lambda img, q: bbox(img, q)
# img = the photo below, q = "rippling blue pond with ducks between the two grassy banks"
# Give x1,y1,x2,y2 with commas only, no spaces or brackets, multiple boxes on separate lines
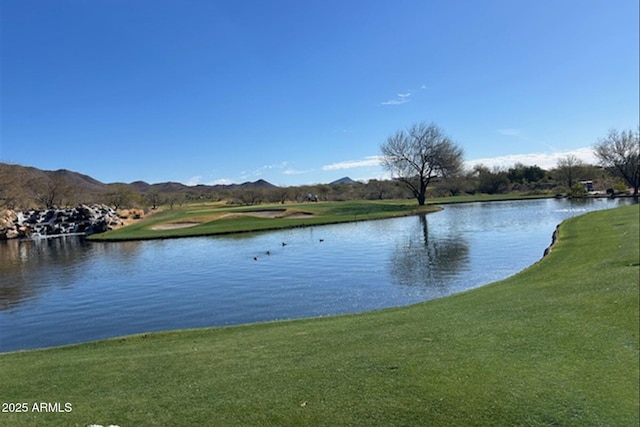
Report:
0,199,631,352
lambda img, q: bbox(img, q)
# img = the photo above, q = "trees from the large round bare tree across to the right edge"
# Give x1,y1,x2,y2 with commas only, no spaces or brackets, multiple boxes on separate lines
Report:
380,123,640,205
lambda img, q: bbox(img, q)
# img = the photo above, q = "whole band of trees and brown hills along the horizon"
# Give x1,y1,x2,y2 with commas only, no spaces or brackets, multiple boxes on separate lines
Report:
0,123,640,209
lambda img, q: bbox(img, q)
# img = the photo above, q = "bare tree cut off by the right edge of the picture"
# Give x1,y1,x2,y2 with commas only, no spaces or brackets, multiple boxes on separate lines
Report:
594,128,640,197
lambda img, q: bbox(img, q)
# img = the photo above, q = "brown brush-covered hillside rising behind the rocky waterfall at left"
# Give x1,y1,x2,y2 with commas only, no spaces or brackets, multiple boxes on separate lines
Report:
0,162,277,209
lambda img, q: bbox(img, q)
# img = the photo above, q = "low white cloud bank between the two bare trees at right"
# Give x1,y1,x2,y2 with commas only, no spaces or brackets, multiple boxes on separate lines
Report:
464,147,598,169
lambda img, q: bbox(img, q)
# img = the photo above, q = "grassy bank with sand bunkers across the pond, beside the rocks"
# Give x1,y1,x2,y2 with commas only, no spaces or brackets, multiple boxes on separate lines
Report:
90,200,437,241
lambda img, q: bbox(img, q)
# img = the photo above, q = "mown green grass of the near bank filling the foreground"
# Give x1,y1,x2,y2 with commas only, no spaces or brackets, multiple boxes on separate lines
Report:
0,205,640,427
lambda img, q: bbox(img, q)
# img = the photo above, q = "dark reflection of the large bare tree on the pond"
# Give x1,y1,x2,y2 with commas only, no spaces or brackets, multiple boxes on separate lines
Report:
389,215,469,288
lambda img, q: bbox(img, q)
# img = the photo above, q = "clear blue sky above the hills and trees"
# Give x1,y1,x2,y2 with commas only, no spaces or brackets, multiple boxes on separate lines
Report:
0,0,640,185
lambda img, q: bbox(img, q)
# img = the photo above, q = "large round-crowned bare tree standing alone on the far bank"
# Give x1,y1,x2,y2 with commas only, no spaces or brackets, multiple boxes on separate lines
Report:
380,123,463,206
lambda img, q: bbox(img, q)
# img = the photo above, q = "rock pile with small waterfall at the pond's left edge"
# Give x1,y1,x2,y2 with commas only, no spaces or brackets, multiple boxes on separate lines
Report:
0,205,144,240
